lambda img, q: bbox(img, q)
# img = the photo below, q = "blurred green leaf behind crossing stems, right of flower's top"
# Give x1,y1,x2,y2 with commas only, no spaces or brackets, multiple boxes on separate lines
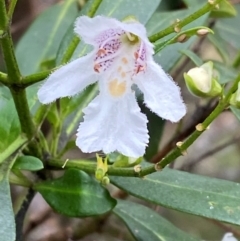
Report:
146,6,208,71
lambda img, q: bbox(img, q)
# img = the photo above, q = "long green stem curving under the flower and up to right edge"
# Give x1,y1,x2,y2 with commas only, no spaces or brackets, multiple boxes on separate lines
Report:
48,75,240,177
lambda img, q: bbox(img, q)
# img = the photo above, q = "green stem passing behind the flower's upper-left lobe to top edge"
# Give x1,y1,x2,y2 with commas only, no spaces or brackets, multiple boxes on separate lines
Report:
61,0,102,64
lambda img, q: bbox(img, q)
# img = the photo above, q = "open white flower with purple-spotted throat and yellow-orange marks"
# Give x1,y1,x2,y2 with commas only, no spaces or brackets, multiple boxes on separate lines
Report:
38,16,186,157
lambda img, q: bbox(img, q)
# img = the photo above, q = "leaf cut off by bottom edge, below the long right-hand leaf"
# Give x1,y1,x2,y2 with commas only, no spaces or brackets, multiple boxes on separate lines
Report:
113,200,198,241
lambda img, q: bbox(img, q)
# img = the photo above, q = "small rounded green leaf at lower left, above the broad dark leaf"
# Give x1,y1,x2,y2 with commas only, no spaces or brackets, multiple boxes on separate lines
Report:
12,156,43,171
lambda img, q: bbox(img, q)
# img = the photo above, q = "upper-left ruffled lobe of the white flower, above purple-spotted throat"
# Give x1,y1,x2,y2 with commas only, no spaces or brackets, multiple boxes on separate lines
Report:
74,16,121,45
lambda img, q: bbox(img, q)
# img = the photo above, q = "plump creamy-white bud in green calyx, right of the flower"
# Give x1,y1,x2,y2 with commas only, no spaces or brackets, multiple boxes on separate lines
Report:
184,61,222,97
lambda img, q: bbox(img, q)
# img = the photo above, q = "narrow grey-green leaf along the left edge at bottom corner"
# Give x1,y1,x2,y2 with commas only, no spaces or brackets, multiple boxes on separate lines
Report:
0,160,16,241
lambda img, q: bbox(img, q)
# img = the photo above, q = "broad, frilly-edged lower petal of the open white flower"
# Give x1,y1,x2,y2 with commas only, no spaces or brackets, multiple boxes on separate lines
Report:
76,93,149,157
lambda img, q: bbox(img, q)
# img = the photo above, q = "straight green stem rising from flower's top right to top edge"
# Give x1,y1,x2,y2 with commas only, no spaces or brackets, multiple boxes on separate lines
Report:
149,0,222,42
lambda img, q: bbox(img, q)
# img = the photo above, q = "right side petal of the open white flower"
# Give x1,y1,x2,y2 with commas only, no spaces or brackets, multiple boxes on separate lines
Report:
135,62,186,122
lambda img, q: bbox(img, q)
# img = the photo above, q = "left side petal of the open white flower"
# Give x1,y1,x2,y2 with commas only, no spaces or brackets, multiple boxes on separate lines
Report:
38,53,98,104
